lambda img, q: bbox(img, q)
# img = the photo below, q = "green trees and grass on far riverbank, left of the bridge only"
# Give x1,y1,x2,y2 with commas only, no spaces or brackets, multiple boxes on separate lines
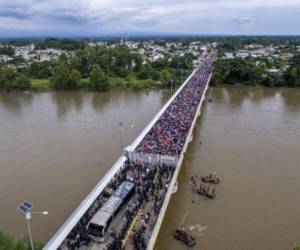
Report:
0,45,194,91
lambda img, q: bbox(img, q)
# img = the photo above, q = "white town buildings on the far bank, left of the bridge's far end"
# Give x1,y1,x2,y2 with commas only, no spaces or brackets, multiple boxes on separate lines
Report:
0,37,213,69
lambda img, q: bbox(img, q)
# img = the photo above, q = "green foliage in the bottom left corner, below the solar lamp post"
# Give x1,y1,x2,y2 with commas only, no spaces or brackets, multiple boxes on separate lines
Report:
0,231,43,250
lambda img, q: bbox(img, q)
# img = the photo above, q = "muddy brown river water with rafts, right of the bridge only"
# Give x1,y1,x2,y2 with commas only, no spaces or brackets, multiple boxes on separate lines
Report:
155,87,300,250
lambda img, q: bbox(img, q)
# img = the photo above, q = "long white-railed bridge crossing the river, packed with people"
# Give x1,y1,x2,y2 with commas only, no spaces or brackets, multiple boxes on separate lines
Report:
44,51,216,250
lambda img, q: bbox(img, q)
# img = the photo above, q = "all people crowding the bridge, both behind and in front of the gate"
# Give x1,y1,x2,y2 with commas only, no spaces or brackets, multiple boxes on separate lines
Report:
60,53,215,250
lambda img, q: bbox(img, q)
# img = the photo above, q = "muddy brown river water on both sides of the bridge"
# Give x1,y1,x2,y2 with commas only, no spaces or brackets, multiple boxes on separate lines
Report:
0,87,300,250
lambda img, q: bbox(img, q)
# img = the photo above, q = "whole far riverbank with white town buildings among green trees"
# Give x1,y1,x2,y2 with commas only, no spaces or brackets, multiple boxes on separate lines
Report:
0,36,300,91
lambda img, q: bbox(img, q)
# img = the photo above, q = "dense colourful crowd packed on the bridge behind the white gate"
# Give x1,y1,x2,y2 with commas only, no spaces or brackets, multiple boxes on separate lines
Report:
135,53,215,156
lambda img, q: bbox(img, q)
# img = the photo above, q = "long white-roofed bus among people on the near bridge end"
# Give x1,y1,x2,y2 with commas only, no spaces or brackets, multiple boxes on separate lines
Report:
87,180,135,242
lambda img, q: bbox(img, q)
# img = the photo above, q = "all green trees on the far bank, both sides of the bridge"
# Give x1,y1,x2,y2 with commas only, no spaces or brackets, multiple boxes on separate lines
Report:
0,36,300,91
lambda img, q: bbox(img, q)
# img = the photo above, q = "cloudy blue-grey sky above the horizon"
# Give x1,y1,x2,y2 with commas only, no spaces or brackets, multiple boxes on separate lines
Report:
0,0,300,37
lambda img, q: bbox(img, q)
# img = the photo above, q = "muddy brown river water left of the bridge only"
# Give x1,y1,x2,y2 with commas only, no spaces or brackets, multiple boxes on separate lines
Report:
0,91,170,241
